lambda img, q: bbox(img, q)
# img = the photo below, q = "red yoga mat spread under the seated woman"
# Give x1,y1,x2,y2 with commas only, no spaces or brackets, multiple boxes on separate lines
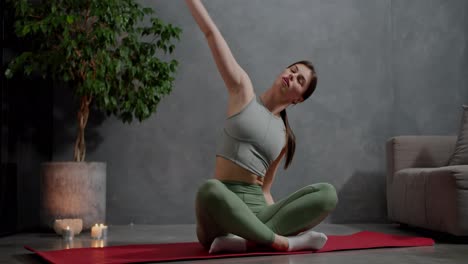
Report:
25,231,434,264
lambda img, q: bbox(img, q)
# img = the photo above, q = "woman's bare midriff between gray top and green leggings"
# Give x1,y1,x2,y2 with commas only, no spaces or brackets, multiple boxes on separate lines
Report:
215,156,263,186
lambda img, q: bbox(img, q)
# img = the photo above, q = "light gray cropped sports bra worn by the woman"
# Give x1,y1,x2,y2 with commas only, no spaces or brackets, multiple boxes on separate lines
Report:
216,95,286,177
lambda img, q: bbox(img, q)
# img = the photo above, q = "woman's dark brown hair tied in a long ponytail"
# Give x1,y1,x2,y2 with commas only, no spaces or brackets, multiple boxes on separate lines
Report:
280,60,317,169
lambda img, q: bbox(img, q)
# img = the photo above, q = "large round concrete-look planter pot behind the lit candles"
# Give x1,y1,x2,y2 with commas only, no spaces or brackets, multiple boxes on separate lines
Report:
40,162,106,230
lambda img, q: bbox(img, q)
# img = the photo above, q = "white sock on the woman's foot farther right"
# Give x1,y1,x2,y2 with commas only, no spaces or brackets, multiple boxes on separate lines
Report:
287,230,328,251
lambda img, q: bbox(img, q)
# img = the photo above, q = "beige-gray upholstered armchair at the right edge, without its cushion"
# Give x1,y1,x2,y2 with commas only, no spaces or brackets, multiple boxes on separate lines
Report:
386,136,468,236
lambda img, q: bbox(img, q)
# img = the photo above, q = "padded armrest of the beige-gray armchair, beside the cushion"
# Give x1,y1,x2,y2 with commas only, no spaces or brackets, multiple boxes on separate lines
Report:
386,136,457,183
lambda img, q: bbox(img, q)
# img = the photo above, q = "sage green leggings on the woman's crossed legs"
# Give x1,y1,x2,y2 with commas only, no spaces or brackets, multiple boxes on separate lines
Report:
195,179,338,248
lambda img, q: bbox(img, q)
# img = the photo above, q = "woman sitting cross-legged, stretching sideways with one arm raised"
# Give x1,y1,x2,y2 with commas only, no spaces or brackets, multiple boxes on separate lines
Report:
186,0,337,253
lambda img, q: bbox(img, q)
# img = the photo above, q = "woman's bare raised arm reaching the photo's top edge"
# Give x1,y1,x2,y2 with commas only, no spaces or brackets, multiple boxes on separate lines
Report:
185,0,253,94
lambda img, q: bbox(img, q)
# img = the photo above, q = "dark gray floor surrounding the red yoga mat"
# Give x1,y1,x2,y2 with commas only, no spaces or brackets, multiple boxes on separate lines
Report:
0,224,468,264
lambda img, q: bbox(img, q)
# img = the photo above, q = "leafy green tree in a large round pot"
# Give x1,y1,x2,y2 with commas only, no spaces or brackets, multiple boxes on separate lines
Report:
5,0,181,229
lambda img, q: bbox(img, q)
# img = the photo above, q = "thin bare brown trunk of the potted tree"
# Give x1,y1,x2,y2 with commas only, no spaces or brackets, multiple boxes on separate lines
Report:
74,95,92,162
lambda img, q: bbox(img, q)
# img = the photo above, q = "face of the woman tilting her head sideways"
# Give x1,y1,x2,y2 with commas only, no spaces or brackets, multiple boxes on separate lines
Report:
275,64,312,104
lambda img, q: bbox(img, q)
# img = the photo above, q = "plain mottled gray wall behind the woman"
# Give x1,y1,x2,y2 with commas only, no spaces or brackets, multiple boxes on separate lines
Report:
50,0,468,224
